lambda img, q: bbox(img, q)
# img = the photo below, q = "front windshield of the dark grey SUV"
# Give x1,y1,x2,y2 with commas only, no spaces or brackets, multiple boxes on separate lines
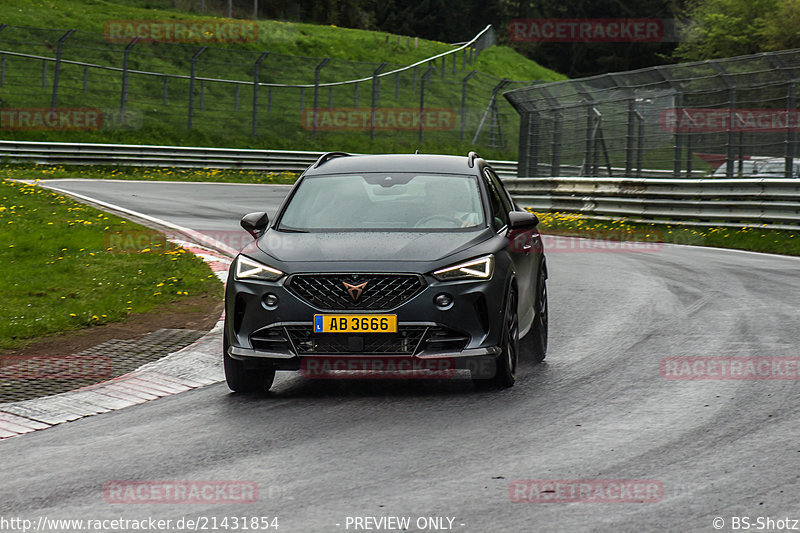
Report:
278,173,485,231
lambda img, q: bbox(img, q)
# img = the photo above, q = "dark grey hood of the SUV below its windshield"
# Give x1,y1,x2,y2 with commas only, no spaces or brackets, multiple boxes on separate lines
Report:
258,228,492,262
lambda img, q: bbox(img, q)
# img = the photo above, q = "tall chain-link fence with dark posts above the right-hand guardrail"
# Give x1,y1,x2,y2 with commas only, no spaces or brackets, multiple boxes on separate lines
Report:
505,50,800,178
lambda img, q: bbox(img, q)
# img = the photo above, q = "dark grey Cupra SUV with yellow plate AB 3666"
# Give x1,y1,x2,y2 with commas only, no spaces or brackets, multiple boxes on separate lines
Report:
224,152,547,391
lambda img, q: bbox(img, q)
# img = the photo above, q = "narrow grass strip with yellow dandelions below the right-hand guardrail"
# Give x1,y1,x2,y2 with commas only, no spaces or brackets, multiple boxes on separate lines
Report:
536,212,800,255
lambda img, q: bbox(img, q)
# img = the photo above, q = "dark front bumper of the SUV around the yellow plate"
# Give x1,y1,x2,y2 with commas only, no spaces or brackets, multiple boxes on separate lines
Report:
225,266,506,370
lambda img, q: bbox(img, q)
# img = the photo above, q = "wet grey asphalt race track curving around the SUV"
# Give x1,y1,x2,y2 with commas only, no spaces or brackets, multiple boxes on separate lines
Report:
0,181,800,532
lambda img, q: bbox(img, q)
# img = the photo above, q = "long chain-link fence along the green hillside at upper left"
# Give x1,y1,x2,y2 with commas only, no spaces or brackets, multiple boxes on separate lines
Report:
0,21,531,151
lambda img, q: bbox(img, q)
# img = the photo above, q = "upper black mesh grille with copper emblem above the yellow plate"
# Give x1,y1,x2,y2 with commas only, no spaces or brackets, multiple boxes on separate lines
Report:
286,274,425,311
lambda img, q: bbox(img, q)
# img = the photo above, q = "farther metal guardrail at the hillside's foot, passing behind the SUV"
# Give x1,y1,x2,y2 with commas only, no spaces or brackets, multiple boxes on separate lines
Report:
0,141,517,178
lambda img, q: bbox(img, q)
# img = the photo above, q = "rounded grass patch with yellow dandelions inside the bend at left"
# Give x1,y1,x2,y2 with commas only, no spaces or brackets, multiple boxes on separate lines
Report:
0,179,222,349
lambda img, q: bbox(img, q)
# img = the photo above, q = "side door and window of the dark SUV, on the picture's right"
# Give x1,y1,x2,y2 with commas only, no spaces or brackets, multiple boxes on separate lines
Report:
483,168,541,324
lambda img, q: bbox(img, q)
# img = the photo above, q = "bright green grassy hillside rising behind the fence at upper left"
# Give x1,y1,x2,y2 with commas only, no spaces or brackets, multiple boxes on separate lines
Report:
0,0,563,157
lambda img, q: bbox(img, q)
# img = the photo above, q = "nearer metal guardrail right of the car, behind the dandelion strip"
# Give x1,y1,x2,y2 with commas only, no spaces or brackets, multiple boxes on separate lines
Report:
503,177,800,230
